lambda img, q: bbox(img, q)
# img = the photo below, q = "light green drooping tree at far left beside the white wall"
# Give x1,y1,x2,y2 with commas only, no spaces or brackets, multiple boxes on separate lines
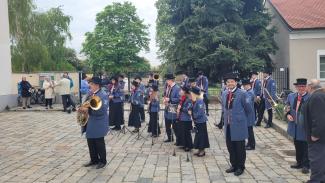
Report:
9,0,75,72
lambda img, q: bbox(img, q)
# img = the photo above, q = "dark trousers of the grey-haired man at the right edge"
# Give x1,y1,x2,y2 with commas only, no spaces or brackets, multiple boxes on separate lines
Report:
308,142,325,183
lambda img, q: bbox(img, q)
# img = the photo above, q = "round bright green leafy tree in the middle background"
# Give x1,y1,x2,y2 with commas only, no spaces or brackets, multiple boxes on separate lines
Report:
82,2,149,73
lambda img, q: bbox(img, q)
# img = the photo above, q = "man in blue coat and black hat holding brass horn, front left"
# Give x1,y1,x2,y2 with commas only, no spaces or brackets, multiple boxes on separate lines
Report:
78,77,108,169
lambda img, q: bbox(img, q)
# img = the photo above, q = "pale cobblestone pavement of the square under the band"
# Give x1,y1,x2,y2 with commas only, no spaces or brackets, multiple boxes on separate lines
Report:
0,108,308,183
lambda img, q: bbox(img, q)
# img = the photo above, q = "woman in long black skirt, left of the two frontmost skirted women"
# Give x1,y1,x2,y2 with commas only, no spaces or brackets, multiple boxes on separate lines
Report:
177,86,193,151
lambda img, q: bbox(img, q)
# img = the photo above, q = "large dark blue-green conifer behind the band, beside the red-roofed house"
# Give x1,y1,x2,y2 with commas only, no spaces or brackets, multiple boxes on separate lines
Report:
157,0,276,78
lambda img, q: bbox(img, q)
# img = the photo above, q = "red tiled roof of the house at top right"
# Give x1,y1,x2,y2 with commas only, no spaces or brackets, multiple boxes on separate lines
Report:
269,0,325,29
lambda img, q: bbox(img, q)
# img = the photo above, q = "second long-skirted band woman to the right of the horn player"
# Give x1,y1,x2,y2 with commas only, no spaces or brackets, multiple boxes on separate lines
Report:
128,81,142,133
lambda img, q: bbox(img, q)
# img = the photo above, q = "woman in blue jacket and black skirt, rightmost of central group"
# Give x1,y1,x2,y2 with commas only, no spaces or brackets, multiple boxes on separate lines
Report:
191,87,210,157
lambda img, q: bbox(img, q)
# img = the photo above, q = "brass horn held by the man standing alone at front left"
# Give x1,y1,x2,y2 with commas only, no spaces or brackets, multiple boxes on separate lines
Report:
77,95,102,126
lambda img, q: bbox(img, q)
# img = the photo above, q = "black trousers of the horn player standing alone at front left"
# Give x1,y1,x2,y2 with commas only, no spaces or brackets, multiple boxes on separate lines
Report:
87,137,107,164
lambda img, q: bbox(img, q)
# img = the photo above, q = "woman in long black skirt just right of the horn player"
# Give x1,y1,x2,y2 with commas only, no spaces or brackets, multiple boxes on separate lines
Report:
108,77,124,130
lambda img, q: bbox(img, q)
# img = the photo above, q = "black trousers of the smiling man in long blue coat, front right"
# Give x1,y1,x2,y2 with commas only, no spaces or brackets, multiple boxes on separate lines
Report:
226,125,246,169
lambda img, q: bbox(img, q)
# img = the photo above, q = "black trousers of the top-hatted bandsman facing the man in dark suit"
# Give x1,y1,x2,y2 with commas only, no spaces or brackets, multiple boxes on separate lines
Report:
294,140,309,168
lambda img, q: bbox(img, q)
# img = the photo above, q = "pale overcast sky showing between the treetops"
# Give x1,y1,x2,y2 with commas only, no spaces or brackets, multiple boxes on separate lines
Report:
35,0,160,66
